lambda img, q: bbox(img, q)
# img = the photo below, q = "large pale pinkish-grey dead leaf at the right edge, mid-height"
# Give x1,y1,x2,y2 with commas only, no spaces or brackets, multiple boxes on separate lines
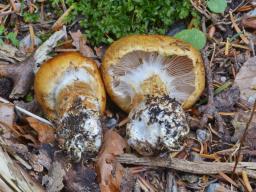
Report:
234,57,256,105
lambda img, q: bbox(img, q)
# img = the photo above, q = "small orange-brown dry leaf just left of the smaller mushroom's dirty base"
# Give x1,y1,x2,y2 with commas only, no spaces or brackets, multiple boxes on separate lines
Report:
26,117,55,143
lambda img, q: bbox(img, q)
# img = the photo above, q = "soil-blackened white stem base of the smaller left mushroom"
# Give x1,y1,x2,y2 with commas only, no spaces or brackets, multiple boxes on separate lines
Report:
57,106,102,161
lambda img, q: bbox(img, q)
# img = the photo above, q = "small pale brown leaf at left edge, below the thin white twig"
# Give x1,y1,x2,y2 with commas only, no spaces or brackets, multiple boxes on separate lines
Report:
0,103,15,129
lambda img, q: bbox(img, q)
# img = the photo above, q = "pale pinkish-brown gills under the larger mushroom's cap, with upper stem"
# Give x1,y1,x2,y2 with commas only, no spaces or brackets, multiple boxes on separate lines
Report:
109,51,195,108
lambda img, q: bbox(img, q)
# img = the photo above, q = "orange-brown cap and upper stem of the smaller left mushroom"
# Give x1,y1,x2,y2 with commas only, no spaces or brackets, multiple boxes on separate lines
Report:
34,52,106,119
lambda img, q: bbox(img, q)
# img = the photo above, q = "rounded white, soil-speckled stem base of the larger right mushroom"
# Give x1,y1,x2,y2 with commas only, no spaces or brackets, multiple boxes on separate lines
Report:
127,96,189,155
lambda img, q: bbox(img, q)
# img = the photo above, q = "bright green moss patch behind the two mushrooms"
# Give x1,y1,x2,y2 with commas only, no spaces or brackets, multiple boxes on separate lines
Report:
52,0,198,46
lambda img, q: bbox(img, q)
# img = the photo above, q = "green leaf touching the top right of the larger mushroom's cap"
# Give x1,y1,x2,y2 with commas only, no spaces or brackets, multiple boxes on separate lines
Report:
175,28,206,49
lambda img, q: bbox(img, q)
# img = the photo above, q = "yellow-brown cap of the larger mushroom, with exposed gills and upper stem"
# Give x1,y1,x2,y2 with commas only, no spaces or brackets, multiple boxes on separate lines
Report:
102,35,205,112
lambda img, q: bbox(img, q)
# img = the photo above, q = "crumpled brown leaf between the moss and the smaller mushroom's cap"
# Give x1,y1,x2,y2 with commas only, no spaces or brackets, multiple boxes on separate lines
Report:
70,30,95,58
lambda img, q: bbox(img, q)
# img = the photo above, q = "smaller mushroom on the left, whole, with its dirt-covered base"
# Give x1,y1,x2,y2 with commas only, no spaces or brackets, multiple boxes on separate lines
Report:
34,52,106,161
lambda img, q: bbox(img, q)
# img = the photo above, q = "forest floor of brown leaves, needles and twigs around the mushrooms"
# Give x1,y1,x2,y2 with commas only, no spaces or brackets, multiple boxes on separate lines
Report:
0,0,256,192
